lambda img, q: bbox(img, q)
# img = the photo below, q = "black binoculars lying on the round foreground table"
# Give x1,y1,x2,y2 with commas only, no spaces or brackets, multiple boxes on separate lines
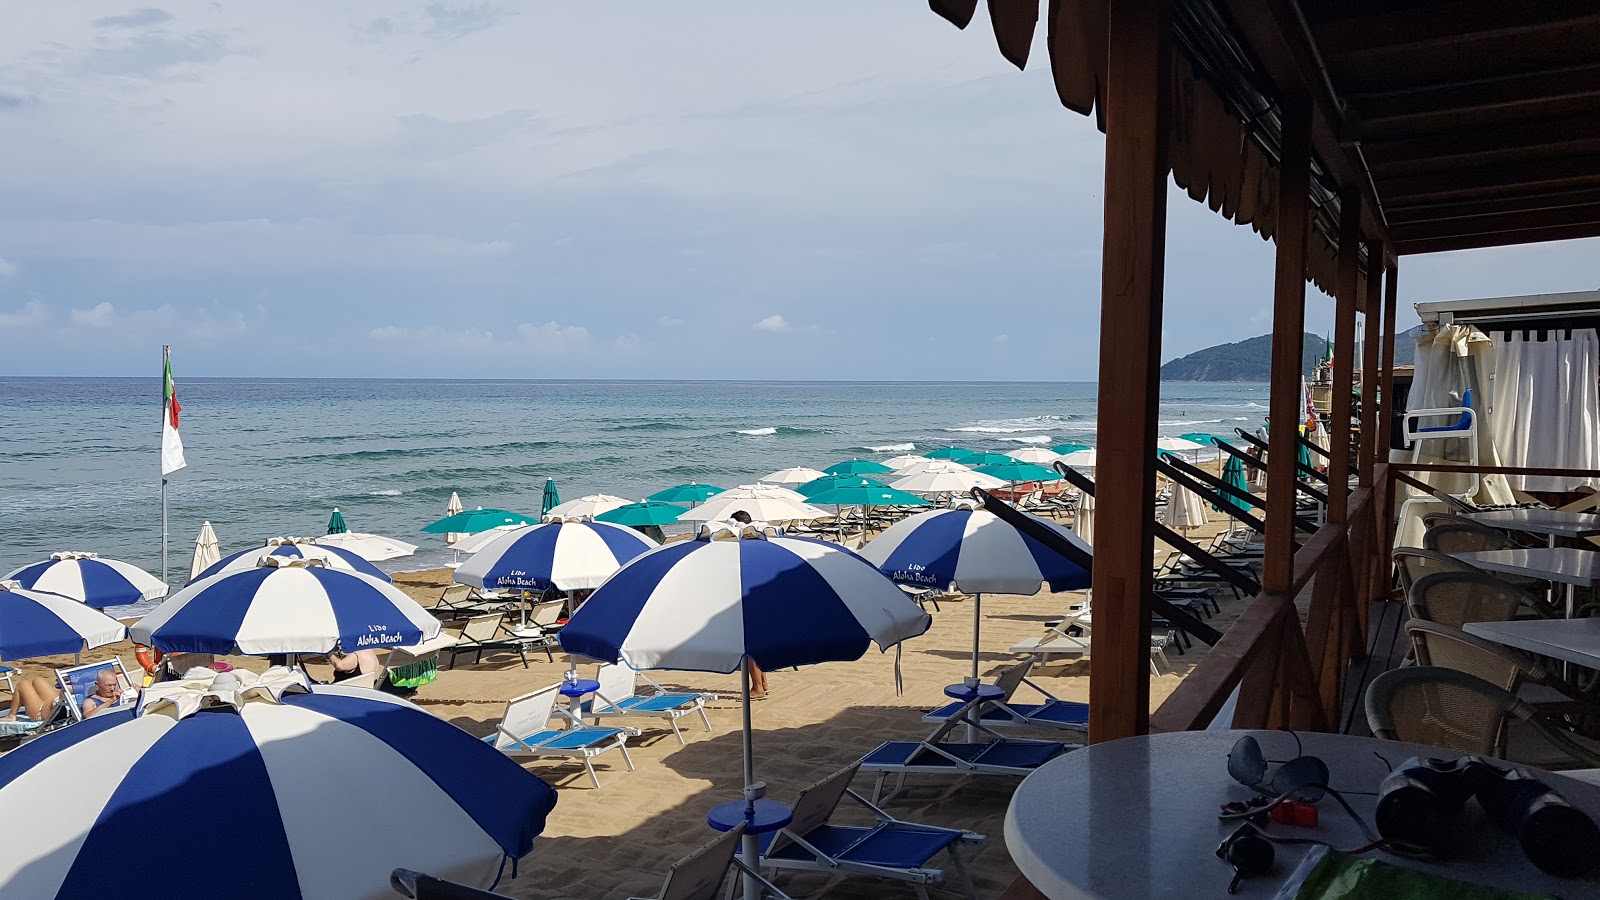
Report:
1376,756,1600,878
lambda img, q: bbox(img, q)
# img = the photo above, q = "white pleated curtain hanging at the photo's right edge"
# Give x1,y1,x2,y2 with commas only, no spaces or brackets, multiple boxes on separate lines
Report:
1488,328,1600,492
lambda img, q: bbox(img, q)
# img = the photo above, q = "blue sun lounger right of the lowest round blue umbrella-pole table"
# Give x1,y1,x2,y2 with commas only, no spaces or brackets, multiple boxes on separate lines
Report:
762,762,984,900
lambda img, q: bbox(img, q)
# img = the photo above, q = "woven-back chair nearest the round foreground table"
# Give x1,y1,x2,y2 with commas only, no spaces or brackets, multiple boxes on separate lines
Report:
1366,666,1600,767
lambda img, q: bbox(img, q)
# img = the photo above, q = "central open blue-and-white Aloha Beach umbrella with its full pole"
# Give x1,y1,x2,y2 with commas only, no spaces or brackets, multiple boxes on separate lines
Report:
560,538,933,900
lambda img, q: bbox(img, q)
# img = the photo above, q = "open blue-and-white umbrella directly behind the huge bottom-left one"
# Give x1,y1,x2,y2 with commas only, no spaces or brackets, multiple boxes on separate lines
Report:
133,556,438,655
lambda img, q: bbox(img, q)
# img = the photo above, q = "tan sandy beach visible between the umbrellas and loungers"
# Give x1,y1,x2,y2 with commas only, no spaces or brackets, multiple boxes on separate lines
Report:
6,493,1242,900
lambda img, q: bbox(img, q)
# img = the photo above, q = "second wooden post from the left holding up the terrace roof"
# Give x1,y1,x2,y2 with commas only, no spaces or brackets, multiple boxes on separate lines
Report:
1260,98,1310,595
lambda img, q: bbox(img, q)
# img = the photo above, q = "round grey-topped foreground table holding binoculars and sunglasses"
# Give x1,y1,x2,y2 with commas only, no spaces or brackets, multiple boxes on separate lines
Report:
1005,732,1600,900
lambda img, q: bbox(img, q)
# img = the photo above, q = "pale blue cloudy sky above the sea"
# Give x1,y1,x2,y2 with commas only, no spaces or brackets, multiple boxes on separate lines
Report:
0,0,1600,381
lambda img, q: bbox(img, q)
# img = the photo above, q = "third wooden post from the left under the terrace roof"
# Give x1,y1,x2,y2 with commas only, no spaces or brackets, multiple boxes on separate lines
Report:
1328,191,1362,522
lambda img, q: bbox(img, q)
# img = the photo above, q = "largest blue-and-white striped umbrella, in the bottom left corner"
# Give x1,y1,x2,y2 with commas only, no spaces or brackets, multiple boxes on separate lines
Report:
0,669,555,900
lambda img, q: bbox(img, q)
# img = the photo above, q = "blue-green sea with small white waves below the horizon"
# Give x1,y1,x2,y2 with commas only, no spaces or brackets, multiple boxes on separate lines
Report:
0,378,1267,595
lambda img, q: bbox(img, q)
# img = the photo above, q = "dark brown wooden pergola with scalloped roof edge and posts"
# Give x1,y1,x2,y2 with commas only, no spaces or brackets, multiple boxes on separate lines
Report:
930,0,1600,741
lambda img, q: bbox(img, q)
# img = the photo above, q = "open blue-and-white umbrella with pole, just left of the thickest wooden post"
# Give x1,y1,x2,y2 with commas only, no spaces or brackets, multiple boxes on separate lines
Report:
861,509,1093,679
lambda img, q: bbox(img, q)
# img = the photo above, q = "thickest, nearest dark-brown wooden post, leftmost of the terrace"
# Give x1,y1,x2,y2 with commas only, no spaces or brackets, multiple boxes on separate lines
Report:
1090,0,1173,741
